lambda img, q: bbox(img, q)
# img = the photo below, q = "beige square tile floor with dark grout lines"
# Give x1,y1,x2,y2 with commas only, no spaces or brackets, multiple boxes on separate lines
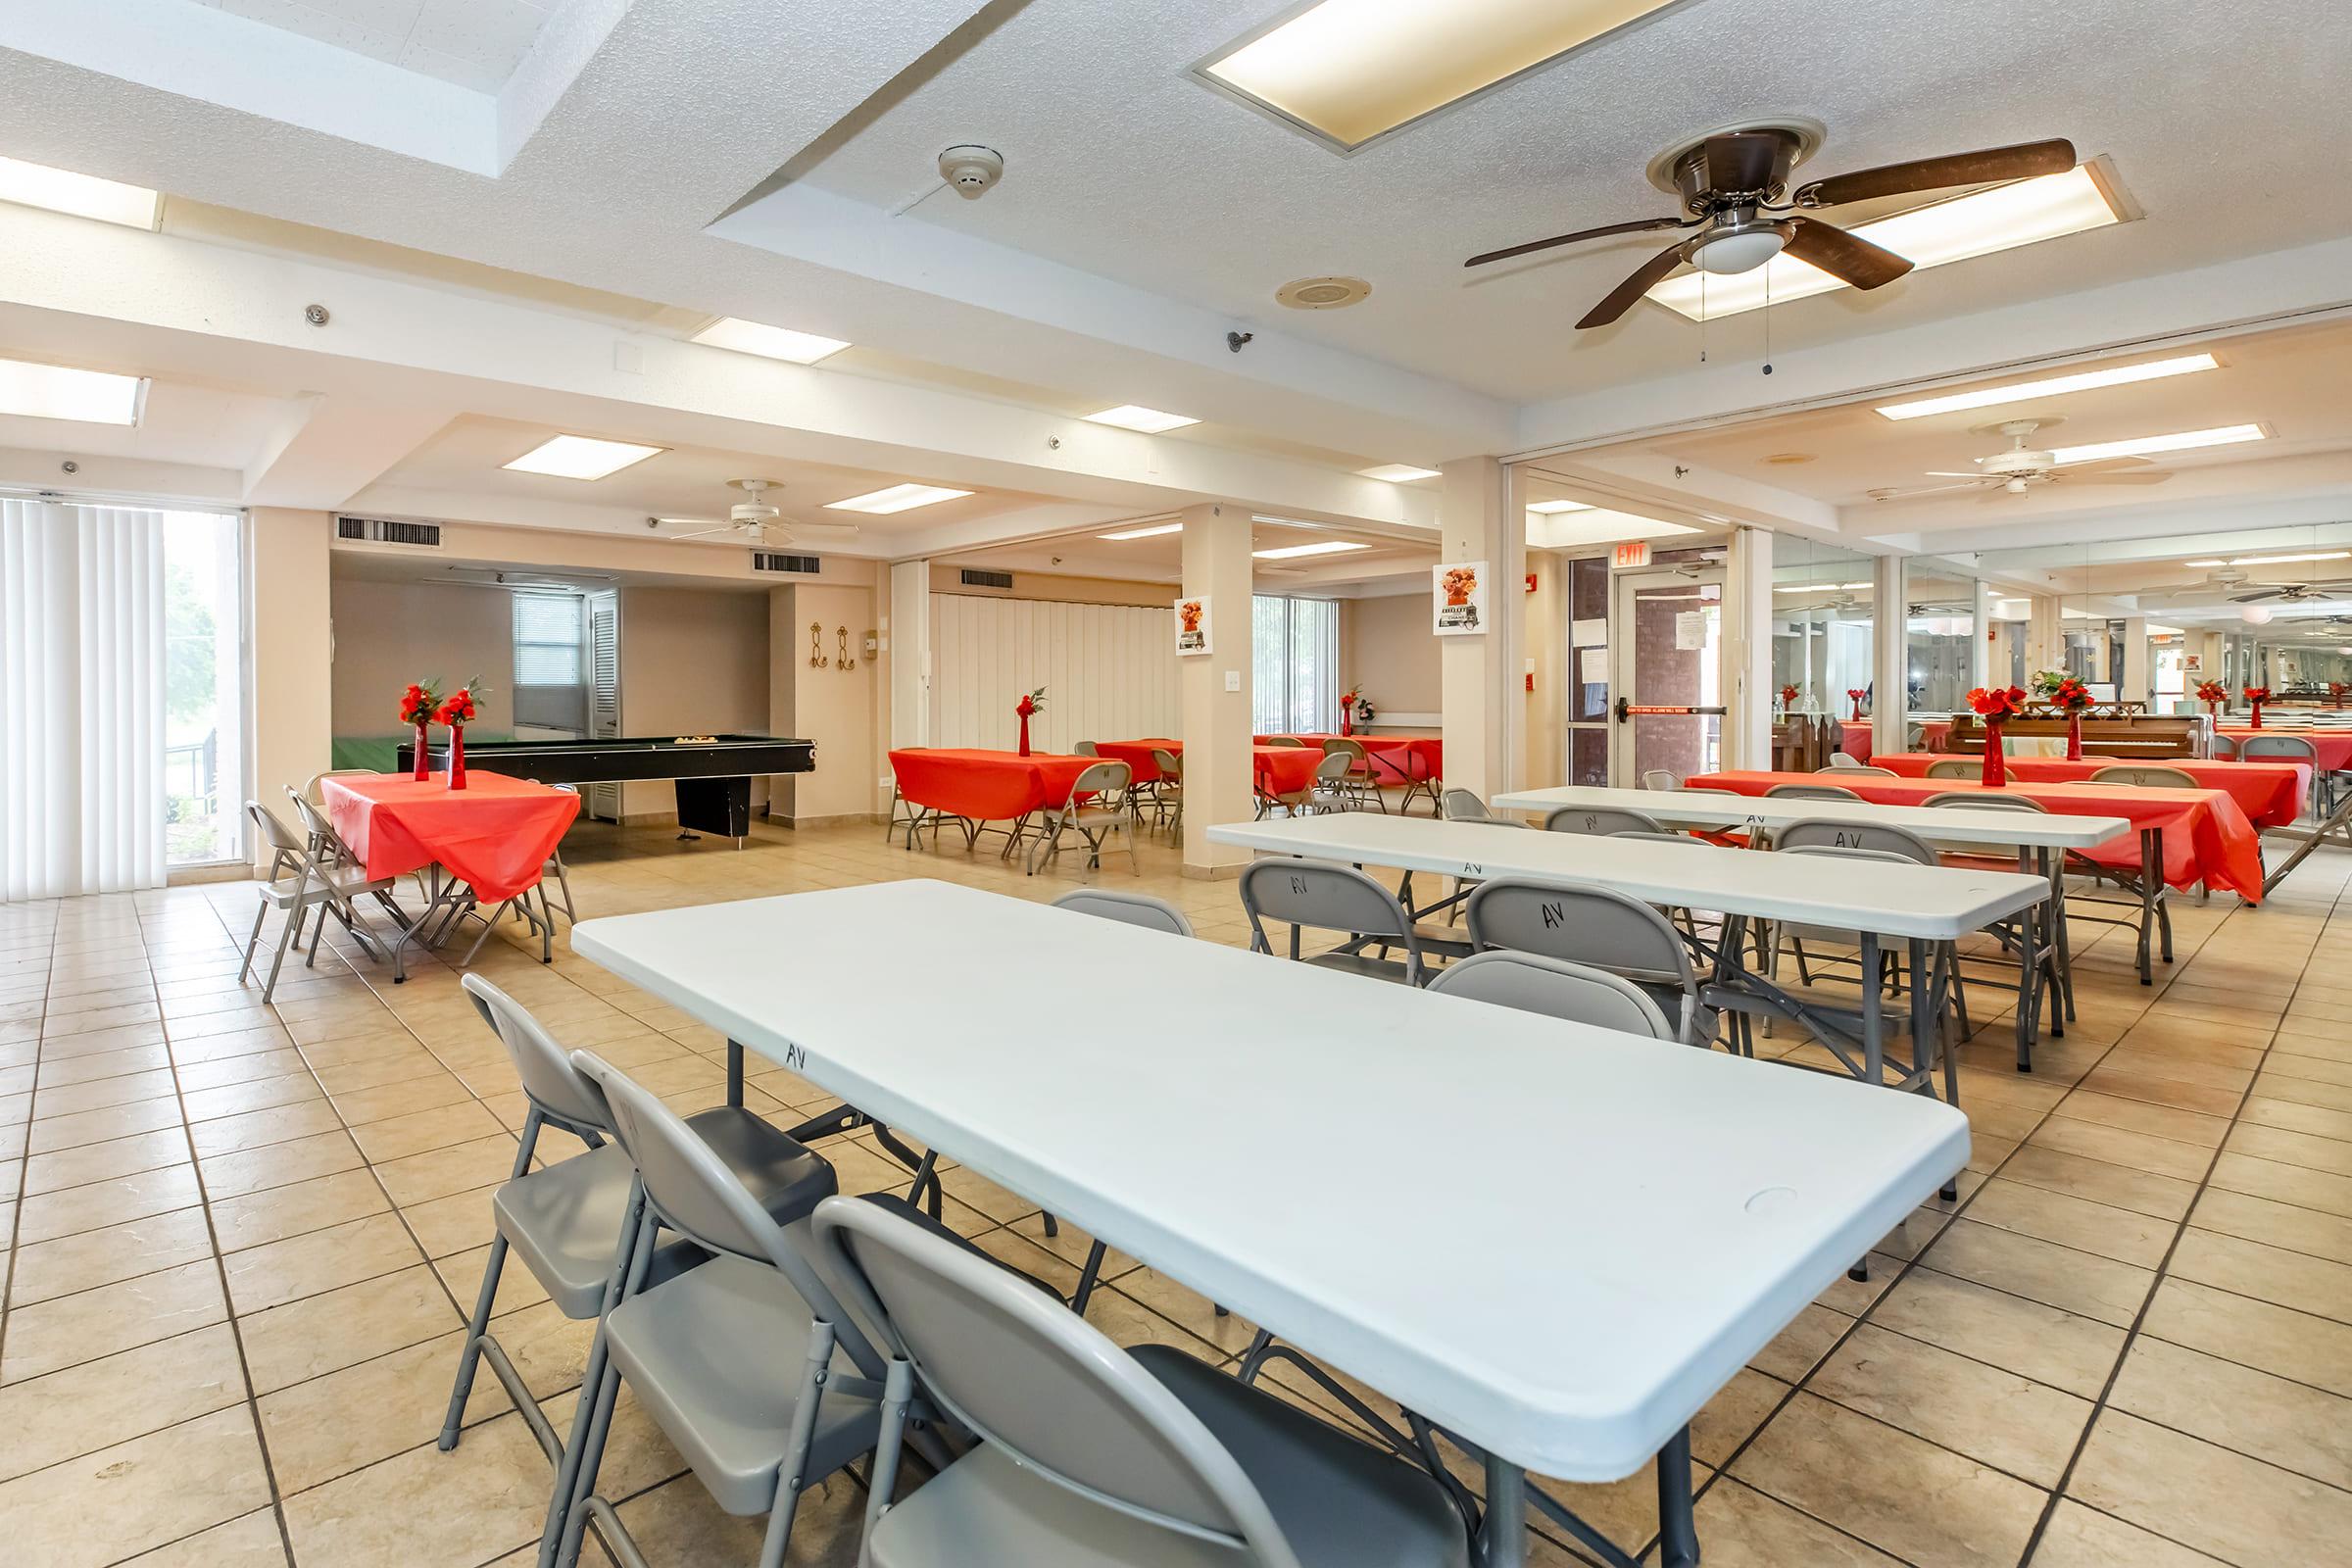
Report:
0,808,2352,1568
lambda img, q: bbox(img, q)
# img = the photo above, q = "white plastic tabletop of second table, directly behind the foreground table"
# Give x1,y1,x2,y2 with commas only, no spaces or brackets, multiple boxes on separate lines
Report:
1209,802,2051,943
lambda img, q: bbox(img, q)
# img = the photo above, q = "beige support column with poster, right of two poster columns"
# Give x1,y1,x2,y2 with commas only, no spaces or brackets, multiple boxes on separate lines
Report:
1437,459,1527,797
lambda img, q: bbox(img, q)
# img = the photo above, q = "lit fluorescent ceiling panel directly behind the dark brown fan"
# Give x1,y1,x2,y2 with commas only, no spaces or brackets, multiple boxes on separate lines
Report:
1648,165,2124,322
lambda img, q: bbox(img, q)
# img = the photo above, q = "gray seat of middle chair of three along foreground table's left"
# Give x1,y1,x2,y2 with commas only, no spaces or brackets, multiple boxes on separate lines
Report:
605,1257,882,1514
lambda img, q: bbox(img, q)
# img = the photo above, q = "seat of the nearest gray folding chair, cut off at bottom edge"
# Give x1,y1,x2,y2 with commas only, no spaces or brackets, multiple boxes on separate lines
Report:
870,1345,1470,1568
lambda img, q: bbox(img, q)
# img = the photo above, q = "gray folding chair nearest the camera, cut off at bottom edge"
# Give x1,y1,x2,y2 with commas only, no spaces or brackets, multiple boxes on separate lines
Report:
816,1199,1470,1568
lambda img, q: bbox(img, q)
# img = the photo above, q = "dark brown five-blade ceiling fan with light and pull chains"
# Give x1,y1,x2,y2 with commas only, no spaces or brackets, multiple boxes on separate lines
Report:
1463,124,2075,329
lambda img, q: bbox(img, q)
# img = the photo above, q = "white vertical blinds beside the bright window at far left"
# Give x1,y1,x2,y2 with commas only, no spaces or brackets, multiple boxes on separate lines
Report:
0,501,165,903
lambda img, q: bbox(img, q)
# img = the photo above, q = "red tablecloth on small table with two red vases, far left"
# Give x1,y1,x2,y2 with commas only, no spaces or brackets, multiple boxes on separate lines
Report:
319,768,581,903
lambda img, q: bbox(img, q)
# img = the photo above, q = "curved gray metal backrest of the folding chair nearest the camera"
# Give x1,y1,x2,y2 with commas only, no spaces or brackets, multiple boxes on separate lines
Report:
816,1197,1298,1568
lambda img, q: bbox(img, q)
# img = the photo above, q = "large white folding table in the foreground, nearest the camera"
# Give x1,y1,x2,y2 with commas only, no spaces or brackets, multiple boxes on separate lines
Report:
571,883,1969,1568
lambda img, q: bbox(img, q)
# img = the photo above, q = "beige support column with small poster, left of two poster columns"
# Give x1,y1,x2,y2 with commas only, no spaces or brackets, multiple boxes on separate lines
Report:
1176,506,1253,877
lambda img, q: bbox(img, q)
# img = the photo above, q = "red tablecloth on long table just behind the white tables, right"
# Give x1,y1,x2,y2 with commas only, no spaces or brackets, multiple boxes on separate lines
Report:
1689,771,2263,903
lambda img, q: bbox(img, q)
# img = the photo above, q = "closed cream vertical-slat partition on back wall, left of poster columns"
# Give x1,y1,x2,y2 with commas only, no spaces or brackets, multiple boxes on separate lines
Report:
929,592,1171,753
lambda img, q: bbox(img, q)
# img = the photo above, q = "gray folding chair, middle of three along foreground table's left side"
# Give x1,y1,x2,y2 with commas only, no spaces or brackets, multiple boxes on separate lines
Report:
541,1051,884,1568
